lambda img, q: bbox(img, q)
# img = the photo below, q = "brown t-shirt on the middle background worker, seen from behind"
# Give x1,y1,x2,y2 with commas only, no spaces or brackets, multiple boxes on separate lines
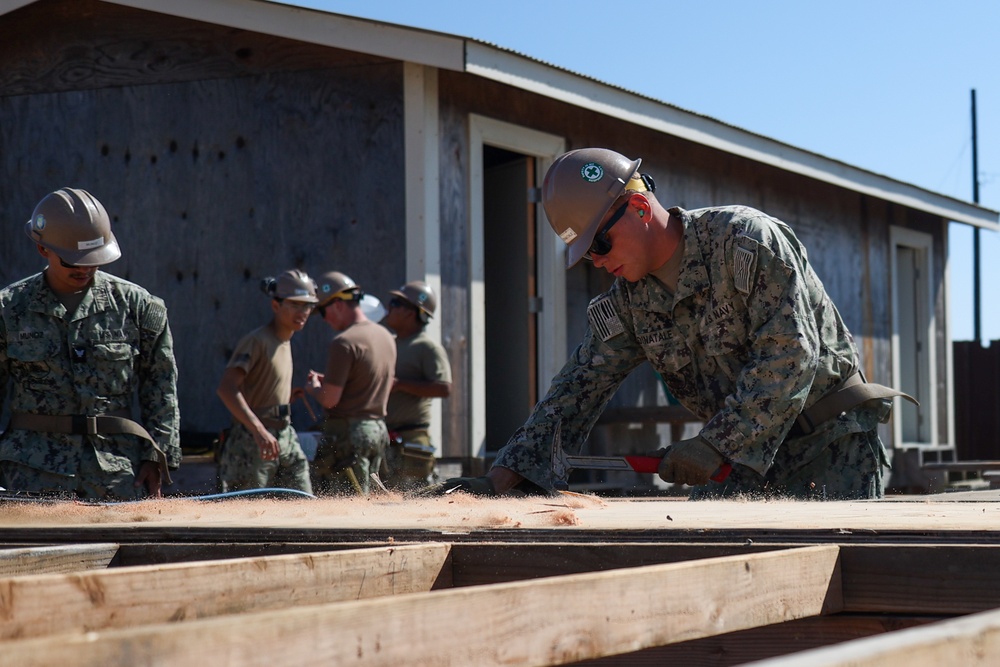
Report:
324,320,396,419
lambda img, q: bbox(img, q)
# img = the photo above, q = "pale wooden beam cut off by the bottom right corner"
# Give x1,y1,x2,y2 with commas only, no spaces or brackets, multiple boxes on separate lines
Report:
751,609,1000,667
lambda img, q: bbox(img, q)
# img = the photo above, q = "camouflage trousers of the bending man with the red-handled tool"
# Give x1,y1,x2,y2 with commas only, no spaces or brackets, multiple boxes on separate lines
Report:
691,430,887,500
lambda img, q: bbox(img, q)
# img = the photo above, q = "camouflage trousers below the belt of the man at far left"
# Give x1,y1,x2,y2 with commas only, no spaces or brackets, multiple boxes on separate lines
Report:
0,446,148,500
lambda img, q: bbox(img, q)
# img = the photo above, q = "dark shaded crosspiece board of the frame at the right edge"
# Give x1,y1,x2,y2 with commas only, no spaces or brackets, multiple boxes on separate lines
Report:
840,545,1000,615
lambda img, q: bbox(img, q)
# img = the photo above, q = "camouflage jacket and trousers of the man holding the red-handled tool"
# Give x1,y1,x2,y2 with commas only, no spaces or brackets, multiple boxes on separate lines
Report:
494,206,891,498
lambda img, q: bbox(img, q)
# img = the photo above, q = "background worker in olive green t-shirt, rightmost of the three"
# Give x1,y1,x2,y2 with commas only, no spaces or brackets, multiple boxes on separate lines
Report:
382,280,451,489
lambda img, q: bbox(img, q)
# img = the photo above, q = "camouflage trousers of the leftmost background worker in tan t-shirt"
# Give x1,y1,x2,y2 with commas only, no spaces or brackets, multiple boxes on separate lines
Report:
219,424,312,493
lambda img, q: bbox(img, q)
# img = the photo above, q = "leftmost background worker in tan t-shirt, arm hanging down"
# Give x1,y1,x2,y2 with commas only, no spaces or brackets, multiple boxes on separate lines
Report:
216,269,319,493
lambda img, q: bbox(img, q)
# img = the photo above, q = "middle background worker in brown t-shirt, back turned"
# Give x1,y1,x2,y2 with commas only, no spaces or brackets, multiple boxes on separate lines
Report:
305,271,396,495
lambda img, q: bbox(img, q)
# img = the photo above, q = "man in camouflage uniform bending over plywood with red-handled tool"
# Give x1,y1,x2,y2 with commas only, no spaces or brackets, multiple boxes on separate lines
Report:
442,149,897,498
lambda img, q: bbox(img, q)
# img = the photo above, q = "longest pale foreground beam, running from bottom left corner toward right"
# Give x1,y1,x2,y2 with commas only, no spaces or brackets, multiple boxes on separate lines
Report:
0,546,842,667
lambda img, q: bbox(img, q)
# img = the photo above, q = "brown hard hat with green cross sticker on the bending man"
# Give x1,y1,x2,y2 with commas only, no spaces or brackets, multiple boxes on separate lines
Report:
542,148,652,268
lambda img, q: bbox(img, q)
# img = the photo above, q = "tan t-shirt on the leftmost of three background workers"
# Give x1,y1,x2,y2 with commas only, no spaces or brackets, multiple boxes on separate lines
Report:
226,324,292,410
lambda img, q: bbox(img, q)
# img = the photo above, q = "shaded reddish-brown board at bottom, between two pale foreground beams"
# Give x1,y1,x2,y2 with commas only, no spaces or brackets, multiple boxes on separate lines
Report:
573,614,950,667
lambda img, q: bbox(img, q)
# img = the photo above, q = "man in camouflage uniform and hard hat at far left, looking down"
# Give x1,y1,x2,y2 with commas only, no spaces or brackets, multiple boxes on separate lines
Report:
0,188,181,500
